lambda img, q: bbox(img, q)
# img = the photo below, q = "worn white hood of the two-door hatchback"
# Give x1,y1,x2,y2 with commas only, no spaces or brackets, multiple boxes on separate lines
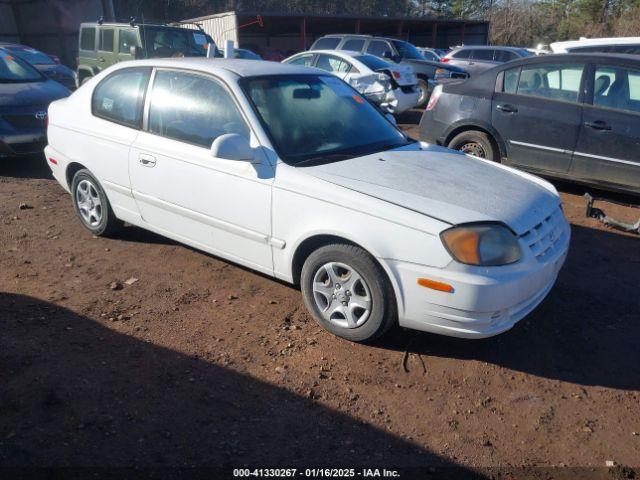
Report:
300,144,560,235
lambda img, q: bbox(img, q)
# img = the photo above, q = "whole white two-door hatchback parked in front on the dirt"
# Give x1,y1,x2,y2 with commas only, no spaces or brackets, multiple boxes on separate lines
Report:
45,58,570,341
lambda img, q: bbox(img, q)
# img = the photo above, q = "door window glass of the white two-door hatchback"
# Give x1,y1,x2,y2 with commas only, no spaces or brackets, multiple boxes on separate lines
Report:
148,70,249,148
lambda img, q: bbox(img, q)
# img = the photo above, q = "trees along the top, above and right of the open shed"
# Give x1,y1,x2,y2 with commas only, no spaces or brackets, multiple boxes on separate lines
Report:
114,0,640,46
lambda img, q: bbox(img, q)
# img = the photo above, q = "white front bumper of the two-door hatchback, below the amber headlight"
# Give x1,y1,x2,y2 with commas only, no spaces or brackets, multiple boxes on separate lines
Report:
389,216,570,338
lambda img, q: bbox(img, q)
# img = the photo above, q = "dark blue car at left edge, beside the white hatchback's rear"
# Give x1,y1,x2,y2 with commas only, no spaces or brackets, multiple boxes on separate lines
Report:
0,48,69,158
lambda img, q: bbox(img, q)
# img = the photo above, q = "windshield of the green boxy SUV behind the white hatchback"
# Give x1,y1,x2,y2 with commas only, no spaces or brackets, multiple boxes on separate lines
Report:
141,27,213,58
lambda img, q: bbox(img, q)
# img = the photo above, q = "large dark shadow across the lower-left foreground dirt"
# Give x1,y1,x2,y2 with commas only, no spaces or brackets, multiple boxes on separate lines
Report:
0,293,477,478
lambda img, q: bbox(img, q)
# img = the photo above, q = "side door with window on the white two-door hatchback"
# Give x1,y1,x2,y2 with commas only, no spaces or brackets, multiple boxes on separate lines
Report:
129,69,274,273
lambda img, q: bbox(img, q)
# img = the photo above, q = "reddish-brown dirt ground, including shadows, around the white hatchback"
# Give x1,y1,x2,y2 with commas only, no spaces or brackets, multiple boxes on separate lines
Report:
0,112,640,478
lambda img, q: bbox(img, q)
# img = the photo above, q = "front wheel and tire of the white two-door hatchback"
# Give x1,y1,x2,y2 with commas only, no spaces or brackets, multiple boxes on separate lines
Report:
300,243,398,342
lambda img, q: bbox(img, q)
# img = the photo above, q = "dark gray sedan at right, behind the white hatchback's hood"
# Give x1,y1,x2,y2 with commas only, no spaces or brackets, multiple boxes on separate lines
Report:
420,54,640,194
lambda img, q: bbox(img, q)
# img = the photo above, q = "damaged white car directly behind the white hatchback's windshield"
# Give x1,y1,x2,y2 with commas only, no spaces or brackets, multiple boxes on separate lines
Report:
282,50,420,115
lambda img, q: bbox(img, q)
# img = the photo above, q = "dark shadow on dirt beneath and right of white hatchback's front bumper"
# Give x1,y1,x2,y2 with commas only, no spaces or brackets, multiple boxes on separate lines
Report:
377,225,640,390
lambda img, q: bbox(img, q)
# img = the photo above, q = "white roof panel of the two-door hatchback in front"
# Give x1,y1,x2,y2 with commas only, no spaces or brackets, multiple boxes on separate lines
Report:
110,57,327,77
